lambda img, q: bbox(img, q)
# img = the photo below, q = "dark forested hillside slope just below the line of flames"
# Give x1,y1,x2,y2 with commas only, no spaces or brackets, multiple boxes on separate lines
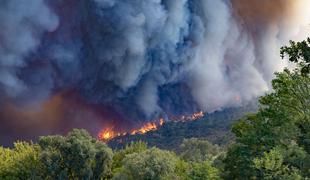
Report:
108,102,257,151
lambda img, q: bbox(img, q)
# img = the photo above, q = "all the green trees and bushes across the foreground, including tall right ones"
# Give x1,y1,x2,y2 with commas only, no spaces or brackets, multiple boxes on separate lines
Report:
0,39,310,180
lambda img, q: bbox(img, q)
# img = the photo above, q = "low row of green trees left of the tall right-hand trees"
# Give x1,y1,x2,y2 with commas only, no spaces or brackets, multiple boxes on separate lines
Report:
0,129,221,180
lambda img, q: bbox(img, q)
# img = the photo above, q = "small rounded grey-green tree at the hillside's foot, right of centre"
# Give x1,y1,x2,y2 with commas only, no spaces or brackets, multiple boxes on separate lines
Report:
180,138,220,162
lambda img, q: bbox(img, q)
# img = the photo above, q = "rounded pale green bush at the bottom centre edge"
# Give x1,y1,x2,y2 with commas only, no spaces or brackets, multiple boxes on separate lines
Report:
113,148,177,180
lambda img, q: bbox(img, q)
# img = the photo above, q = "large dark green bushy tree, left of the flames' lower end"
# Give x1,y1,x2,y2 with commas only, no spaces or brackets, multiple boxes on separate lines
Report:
39,129,112,179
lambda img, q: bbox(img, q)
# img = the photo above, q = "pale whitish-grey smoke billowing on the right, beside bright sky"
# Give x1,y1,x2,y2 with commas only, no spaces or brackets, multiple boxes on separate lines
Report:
191,0,310,111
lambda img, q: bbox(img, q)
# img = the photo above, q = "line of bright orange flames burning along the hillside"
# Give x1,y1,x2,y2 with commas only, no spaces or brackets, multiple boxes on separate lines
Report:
98,111,204,142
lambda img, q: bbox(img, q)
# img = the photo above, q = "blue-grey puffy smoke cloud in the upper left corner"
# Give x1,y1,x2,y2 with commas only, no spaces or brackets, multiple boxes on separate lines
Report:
0,0,58,97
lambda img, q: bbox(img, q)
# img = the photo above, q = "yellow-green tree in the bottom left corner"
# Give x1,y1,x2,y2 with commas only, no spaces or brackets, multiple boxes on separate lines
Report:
0,142,42,180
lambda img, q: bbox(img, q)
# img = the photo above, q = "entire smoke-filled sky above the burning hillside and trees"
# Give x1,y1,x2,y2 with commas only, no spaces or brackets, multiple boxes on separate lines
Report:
0,0,310,144
